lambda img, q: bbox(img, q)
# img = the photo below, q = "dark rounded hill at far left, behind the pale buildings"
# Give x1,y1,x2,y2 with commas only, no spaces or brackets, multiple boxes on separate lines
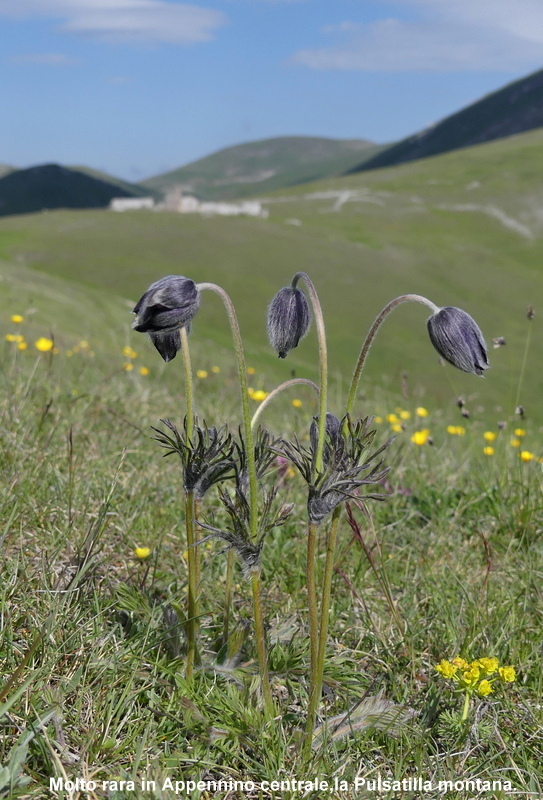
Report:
0,164,149,216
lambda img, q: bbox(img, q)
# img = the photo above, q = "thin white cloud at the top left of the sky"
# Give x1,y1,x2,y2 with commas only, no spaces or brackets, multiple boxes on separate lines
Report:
0,0,226,44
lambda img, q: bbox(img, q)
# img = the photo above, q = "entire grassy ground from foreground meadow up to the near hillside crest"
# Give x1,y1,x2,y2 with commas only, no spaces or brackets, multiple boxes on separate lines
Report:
0,132,543,800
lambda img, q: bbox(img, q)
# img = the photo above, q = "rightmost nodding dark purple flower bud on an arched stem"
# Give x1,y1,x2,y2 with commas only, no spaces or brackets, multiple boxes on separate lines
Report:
427,306,489,375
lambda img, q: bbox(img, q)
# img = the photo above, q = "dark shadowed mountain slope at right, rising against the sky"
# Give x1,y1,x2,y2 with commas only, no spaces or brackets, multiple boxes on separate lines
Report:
352,70,543,173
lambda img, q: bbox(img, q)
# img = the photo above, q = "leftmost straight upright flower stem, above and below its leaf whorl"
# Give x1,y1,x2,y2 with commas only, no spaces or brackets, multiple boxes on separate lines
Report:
180,328,200,682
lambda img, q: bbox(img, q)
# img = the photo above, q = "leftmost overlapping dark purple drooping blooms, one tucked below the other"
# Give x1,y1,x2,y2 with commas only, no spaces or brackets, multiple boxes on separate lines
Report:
132,275,200,362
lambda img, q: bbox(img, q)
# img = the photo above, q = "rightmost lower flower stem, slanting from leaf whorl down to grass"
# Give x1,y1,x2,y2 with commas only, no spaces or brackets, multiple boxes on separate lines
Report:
303,506,341,763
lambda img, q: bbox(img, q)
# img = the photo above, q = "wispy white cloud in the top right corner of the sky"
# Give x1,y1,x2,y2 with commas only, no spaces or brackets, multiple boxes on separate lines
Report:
293,0,543,72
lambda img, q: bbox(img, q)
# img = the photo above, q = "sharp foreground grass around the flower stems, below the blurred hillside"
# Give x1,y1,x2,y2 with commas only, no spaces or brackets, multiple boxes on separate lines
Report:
0,266,543,800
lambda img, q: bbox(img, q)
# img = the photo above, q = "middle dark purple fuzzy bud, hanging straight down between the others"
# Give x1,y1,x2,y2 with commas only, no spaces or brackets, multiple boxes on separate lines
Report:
268,286,309,358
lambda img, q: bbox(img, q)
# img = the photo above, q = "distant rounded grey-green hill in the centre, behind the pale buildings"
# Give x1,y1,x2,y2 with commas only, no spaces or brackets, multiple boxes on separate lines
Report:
142,136,379,200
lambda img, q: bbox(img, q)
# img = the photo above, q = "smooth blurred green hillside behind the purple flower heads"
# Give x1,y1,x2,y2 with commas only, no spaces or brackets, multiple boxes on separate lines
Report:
0,131,543,422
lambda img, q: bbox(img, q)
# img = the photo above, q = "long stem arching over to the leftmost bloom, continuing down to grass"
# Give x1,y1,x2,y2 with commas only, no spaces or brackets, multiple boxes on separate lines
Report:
197,283,274,716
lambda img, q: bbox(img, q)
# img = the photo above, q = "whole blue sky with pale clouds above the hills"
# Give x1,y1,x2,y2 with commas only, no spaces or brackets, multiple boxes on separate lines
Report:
0,0,543,180
